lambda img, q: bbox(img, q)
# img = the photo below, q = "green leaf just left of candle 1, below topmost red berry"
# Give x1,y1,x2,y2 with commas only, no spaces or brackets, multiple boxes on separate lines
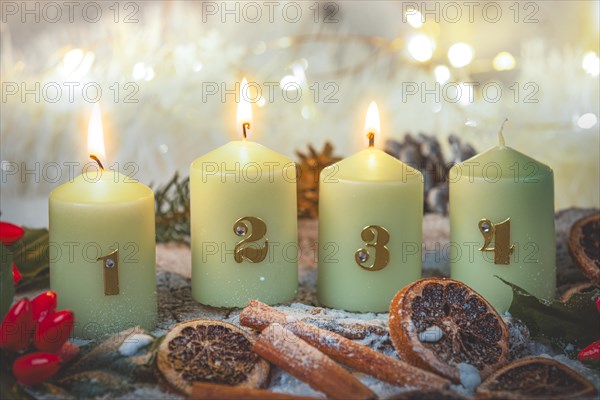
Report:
11,228,50,285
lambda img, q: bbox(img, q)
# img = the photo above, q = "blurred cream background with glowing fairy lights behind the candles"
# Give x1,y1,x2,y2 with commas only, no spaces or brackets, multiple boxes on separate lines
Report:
0,1,600,226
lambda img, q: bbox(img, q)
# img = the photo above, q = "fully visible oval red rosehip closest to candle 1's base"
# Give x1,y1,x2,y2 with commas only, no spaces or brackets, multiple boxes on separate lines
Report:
33,310,75,353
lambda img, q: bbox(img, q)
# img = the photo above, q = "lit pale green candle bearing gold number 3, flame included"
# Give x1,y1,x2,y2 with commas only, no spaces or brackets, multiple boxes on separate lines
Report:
318,103,423,312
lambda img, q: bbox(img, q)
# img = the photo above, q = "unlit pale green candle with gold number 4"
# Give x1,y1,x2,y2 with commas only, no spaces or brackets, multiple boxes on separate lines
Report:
448,120,556,313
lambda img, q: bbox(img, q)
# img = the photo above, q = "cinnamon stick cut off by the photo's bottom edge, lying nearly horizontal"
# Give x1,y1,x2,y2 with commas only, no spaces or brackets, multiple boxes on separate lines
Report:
189,383,316,400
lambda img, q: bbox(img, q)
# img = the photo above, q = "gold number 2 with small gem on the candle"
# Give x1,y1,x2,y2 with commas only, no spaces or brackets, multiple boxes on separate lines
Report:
233,217,269,263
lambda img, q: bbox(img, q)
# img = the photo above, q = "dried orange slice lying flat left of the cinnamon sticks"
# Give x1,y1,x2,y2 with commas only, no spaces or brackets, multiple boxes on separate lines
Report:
156,319,270,394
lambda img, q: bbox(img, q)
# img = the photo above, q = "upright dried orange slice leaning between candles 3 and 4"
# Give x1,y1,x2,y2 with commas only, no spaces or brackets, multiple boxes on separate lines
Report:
389,278,509,383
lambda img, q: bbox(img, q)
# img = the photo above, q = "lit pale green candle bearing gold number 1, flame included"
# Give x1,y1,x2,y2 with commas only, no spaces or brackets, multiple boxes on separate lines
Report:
49,104,157,338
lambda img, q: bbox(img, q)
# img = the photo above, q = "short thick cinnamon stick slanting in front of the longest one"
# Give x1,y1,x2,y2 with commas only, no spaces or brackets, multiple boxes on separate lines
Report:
252,324,376,400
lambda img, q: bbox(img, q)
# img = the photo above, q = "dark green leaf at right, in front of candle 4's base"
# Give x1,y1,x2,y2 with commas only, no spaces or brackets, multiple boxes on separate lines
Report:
497,277,600,356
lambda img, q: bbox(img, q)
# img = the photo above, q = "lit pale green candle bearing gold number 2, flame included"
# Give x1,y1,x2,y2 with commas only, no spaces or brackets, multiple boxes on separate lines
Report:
190,79,298,307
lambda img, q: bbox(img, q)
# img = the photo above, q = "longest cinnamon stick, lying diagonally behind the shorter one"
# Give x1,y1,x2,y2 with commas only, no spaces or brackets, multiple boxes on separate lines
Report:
240,300,450,389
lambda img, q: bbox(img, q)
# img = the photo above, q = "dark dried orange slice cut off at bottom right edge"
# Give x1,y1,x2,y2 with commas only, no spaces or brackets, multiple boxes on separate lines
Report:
477,357,598,400
